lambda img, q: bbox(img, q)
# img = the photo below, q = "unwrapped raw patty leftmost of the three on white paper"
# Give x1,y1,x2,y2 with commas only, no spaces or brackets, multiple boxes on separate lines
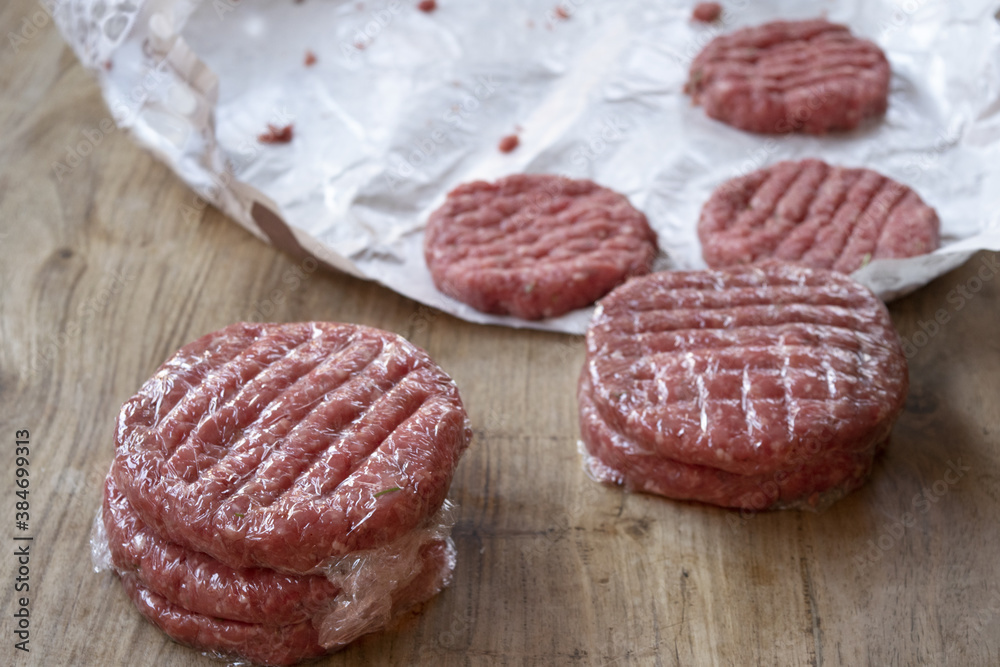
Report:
424,174,656,320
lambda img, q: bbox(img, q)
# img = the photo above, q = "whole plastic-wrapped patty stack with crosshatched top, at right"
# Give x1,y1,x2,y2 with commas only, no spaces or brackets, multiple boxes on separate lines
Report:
578,262,908,510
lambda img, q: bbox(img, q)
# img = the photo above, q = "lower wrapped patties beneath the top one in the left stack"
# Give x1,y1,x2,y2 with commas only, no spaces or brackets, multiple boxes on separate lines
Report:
91,492,456,664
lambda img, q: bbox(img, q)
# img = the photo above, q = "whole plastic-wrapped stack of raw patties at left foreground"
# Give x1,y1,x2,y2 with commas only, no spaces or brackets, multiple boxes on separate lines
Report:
101,323,471,665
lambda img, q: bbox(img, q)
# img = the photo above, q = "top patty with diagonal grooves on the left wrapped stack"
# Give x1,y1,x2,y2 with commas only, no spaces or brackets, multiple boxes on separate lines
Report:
113,322,471,574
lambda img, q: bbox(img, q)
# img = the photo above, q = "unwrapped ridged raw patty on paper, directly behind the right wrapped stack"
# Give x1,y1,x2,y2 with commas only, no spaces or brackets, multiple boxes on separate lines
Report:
698,160,941,273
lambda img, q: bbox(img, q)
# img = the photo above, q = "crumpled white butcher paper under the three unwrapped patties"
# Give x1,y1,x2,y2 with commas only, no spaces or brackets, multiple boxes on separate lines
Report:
54,0,1000,333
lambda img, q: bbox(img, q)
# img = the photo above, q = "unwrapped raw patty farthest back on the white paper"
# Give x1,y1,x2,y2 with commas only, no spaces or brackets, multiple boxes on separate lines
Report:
686,19,890,134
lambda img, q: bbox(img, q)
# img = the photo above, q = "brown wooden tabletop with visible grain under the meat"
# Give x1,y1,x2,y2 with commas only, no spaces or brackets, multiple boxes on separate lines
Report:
0,0,1000,667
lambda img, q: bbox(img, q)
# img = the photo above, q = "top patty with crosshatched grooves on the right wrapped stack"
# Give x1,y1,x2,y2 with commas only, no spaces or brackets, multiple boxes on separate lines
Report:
584,262,906,474
